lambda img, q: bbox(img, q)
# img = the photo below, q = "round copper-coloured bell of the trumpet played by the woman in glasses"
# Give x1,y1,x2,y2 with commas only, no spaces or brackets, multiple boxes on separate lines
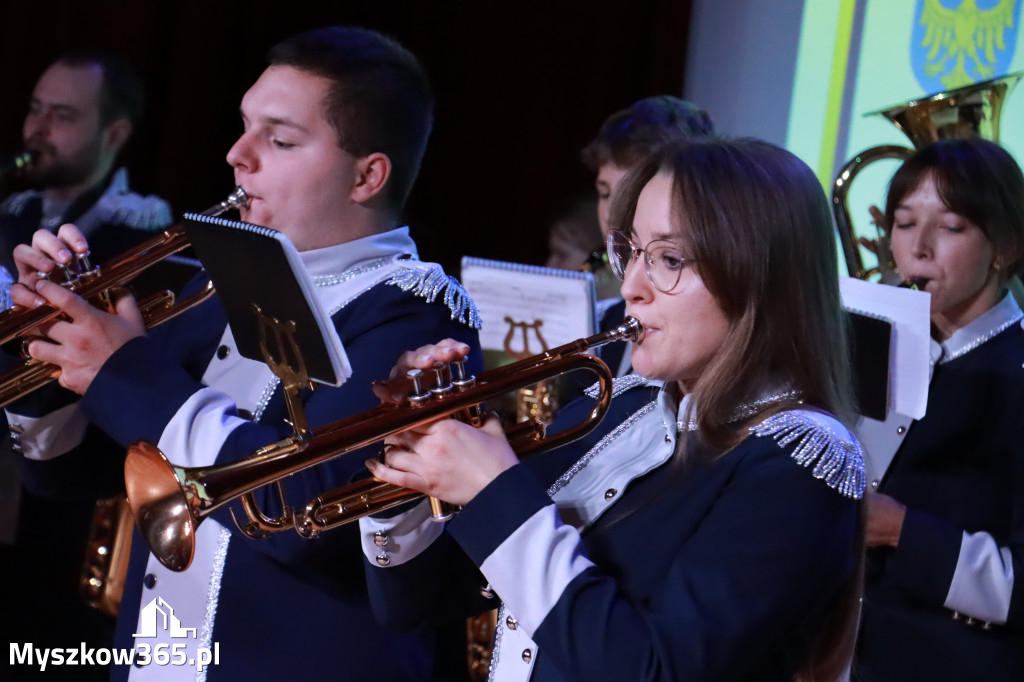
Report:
125,442,200,570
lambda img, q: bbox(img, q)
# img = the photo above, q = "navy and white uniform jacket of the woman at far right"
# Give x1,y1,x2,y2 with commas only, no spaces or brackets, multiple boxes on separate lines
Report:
857,294,1024,680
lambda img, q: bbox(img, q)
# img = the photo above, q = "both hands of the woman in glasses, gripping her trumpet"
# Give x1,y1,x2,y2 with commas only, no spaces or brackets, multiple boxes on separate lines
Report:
367,339,519,505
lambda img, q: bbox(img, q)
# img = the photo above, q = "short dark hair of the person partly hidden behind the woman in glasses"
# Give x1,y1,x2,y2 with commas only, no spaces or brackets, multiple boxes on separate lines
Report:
580,95,715,173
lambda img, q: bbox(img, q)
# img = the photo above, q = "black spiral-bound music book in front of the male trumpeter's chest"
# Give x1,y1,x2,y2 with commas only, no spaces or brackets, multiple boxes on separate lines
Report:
184,213,352,386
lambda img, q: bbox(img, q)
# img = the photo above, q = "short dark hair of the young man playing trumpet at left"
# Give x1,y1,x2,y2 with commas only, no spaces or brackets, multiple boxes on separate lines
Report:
267,27,434,209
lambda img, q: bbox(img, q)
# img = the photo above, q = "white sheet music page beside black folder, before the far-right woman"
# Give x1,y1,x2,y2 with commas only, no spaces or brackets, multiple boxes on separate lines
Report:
840,278,932,419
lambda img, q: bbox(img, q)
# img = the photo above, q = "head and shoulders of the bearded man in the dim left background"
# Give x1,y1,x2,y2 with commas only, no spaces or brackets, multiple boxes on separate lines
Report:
0,51,173,275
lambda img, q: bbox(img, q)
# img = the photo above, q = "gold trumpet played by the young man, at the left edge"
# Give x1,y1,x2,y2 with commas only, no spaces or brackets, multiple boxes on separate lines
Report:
0,187,249,408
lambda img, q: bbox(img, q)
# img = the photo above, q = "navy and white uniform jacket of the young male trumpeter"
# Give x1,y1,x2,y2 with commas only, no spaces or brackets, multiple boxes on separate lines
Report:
9,228,481,682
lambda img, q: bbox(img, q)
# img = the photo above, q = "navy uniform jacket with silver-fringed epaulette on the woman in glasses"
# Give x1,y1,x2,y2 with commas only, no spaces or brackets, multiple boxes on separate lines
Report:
360,381,863,682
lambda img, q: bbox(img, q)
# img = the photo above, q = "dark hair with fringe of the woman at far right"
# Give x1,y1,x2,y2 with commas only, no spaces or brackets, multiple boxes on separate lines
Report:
886,137,1024,282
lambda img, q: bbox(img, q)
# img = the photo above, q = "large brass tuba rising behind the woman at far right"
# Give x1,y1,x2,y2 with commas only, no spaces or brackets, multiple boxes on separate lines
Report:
833,72,1024,282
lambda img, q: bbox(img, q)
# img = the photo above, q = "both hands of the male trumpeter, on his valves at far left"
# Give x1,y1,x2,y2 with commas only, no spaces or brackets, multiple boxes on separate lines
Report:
10,224,145,393
